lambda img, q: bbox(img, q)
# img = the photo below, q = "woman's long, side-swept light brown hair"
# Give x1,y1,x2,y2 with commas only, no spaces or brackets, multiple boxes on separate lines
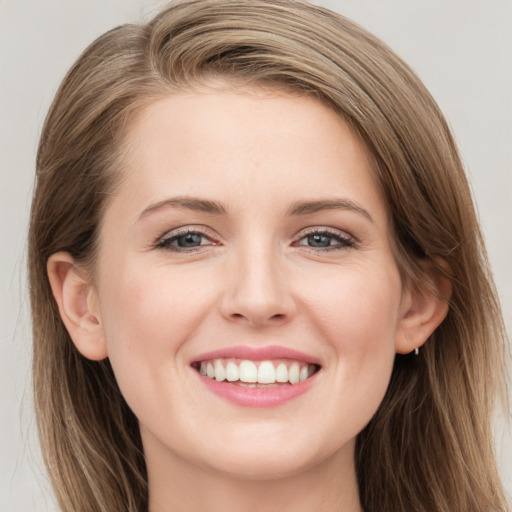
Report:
29,0,507,512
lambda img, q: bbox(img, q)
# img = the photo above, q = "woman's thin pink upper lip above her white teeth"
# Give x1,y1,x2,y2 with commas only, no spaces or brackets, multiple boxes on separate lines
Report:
192,345,320,365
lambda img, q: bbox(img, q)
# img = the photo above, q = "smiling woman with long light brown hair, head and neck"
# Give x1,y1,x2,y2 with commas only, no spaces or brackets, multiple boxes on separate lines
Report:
30,0,506,512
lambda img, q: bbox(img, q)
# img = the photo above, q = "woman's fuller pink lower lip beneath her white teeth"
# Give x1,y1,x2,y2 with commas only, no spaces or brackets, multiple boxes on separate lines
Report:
197,373,317,407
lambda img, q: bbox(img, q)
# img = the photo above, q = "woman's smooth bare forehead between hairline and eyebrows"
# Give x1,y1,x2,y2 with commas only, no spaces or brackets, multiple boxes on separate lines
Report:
111,88,382,222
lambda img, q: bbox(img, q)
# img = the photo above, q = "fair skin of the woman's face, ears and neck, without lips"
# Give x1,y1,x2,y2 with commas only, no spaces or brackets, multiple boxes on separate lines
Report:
48,87,446,512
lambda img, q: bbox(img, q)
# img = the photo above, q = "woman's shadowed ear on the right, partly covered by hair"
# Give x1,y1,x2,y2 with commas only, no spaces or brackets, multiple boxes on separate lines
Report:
395,260,452,354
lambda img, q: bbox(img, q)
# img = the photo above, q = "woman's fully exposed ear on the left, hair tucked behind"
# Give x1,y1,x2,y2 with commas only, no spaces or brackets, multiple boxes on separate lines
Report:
46,252,108,361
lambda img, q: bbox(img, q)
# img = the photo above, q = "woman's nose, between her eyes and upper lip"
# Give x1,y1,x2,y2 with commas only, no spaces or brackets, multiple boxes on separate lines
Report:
221,242,296,328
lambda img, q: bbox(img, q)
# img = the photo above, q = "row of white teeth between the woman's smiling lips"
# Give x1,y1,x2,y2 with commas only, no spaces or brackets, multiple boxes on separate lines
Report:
192,358,320,388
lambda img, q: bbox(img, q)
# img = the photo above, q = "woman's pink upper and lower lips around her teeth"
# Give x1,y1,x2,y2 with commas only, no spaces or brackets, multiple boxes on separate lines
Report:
193,346,319,407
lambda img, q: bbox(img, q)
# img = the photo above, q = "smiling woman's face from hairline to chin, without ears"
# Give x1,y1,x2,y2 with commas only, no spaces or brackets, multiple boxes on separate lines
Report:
95,90,408,478
